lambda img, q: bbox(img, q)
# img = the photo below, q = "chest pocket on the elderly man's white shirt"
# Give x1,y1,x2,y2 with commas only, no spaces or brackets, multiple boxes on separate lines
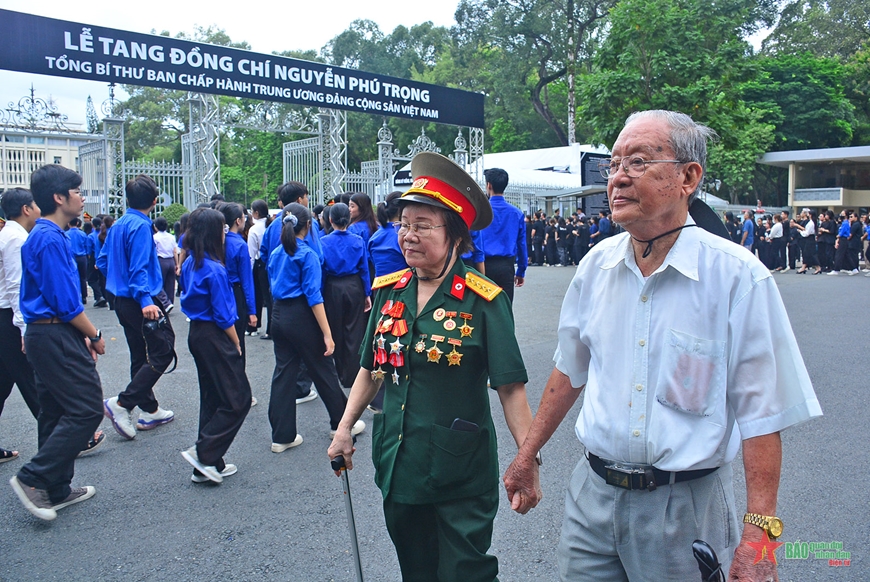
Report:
656,329,725,417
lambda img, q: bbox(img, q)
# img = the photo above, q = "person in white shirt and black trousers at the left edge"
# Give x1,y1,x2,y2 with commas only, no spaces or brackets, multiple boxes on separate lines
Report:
0,188,40,463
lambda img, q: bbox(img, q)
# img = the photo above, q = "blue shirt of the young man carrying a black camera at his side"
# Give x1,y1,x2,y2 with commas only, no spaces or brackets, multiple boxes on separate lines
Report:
100,208,163,309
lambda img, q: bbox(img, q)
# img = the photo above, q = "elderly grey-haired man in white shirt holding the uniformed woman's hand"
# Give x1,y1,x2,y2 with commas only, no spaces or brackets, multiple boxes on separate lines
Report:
504,111,821,582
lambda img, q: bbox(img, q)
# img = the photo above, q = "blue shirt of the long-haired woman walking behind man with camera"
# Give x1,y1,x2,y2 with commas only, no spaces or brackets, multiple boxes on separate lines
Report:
181,255,238,329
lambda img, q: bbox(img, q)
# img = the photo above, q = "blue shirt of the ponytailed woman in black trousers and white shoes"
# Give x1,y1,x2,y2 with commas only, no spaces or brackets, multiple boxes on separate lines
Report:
268,239,323,307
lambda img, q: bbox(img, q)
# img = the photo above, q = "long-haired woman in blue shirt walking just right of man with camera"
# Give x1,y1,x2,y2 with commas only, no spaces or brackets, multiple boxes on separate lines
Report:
181,208,251,483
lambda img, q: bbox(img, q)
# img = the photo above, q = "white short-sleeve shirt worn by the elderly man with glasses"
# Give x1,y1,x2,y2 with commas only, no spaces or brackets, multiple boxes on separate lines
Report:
554,217,822,471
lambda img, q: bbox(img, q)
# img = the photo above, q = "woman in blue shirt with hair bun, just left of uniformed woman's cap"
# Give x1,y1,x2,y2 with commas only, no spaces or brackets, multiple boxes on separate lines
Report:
320,202,372,388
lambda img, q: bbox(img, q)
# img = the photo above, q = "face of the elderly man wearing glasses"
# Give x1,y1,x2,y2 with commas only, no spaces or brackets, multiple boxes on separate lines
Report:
607,118,701,238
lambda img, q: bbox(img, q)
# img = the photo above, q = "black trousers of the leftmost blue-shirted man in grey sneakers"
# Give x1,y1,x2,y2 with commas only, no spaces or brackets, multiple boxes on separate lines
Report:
18,323,103,504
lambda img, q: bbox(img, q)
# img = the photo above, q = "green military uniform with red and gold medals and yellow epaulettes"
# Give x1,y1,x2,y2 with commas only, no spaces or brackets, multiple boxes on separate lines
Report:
361,261,528,582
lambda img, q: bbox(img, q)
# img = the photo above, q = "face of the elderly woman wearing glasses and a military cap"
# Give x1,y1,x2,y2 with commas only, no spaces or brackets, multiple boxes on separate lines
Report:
399,204,450,271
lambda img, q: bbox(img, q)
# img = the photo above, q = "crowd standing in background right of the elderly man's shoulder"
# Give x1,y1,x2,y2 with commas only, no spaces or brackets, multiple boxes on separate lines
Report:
725,208,870,276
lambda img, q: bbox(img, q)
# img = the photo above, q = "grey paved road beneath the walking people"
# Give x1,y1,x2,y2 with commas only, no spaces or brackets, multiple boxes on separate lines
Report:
0,268,870,582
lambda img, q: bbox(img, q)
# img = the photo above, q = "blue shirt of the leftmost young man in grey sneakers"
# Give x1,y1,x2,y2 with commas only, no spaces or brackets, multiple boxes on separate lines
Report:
19,218,84,323
